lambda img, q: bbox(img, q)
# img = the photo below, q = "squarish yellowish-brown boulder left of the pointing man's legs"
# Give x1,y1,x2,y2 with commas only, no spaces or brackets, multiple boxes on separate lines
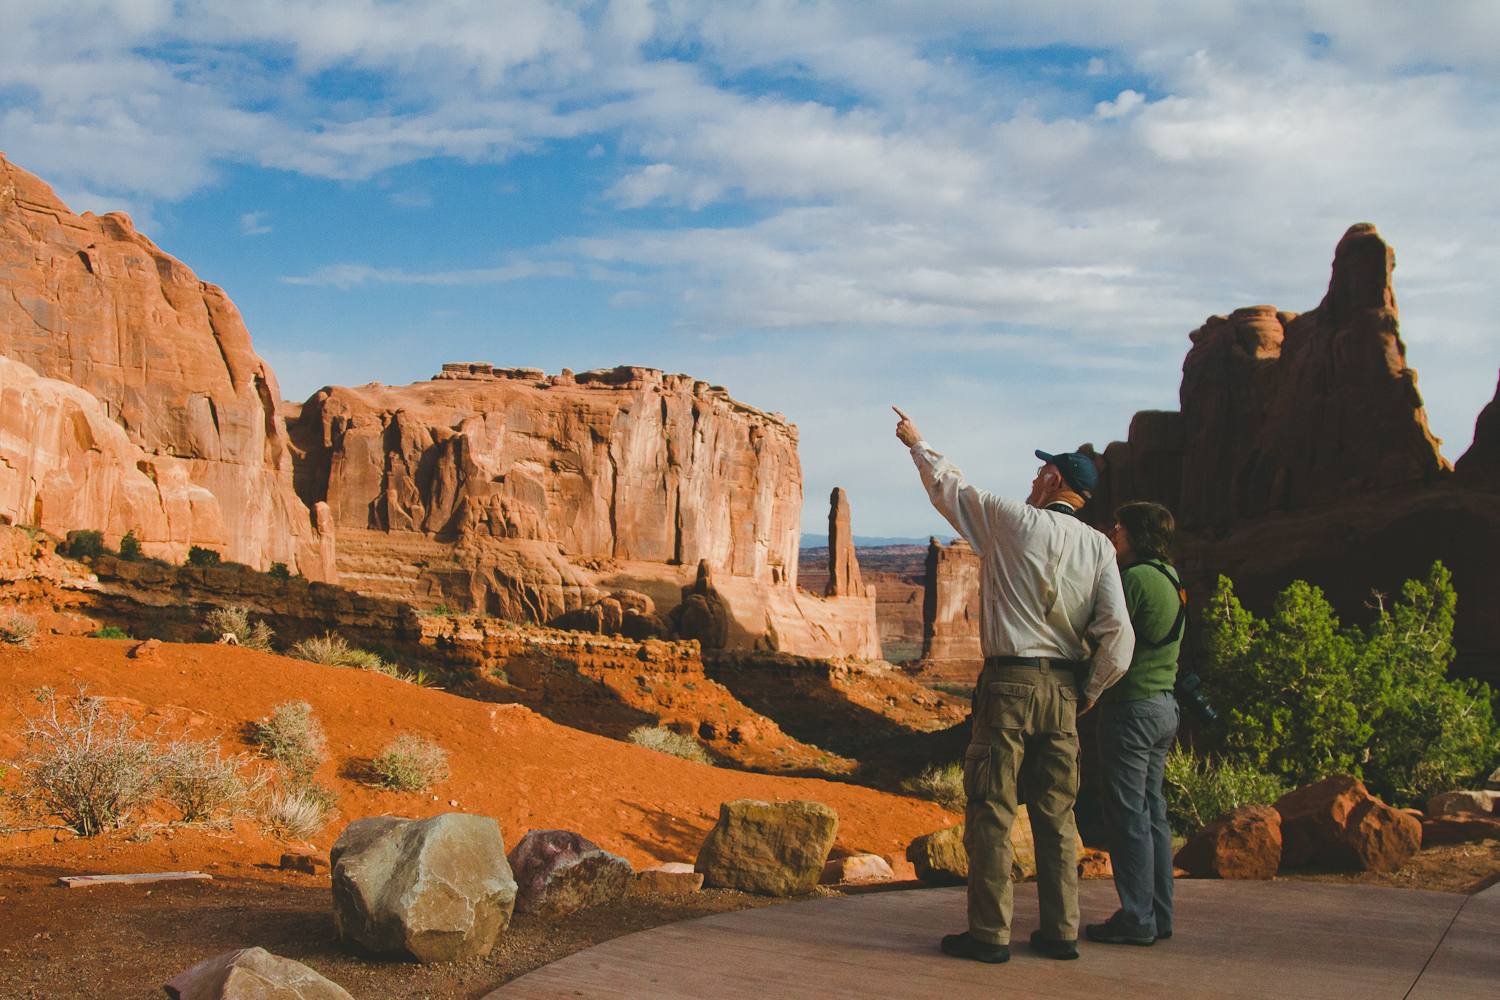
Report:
693,799,839,897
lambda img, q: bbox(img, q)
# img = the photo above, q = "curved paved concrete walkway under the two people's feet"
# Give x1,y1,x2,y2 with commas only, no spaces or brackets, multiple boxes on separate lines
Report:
489,880,1500,1000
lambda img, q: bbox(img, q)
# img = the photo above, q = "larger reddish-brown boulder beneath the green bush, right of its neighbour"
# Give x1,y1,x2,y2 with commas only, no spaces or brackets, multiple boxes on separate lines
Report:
1275,774,1422,871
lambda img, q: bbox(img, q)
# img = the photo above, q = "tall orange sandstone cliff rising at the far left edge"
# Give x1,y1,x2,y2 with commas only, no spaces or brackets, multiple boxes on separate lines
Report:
0,156,329,579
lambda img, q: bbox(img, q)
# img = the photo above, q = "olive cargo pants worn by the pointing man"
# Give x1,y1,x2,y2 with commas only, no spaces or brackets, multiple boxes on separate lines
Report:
963,664,1079,945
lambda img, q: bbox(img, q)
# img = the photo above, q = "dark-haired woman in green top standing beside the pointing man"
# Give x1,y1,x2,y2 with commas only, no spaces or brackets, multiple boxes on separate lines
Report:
1085,504,1188,945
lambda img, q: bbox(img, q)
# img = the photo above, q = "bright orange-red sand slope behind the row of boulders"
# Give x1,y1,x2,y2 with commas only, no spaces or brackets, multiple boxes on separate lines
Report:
0,636,957,874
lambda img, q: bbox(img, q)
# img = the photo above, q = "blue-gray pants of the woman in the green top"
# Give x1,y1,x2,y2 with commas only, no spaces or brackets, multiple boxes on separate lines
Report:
1100,691,1179,937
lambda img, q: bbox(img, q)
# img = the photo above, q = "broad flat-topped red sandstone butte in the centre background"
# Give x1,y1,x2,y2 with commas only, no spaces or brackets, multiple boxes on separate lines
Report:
288,364,879,657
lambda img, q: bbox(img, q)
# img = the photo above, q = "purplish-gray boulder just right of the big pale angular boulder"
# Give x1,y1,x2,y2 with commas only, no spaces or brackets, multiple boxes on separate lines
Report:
507,831,636,916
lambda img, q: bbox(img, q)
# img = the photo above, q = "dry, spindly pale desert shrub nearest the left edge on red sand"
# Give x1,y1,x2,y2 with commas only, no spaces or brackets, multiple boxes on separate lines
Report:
11,688,170,837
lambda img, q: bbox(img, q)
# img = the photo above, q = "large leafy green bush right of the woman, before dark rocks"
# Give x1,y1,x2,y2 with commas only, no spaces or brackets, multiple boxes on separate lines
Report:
1205,562,1500,805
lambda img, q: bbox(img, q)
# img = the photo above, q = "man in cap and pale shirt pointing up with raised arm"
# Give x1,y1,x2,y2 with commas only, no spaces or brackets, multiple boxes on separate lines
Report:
893,406,1136,963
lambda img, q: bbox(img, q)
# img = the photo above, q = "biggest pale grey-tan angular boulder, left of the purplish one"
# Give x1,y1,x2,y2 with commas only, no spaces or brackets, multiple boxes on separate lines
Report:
329,813,516,963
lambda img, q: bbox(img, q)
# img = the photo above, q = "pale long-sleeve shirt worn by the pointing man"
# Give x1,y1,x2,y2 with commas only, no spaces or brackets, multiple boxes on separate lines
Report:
912,441,1136,702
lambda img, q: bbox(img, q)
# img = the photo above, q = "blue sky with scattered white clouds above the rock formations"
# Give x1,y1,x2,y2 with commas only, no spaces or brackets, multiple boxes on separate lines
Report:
0,0,1500,535
